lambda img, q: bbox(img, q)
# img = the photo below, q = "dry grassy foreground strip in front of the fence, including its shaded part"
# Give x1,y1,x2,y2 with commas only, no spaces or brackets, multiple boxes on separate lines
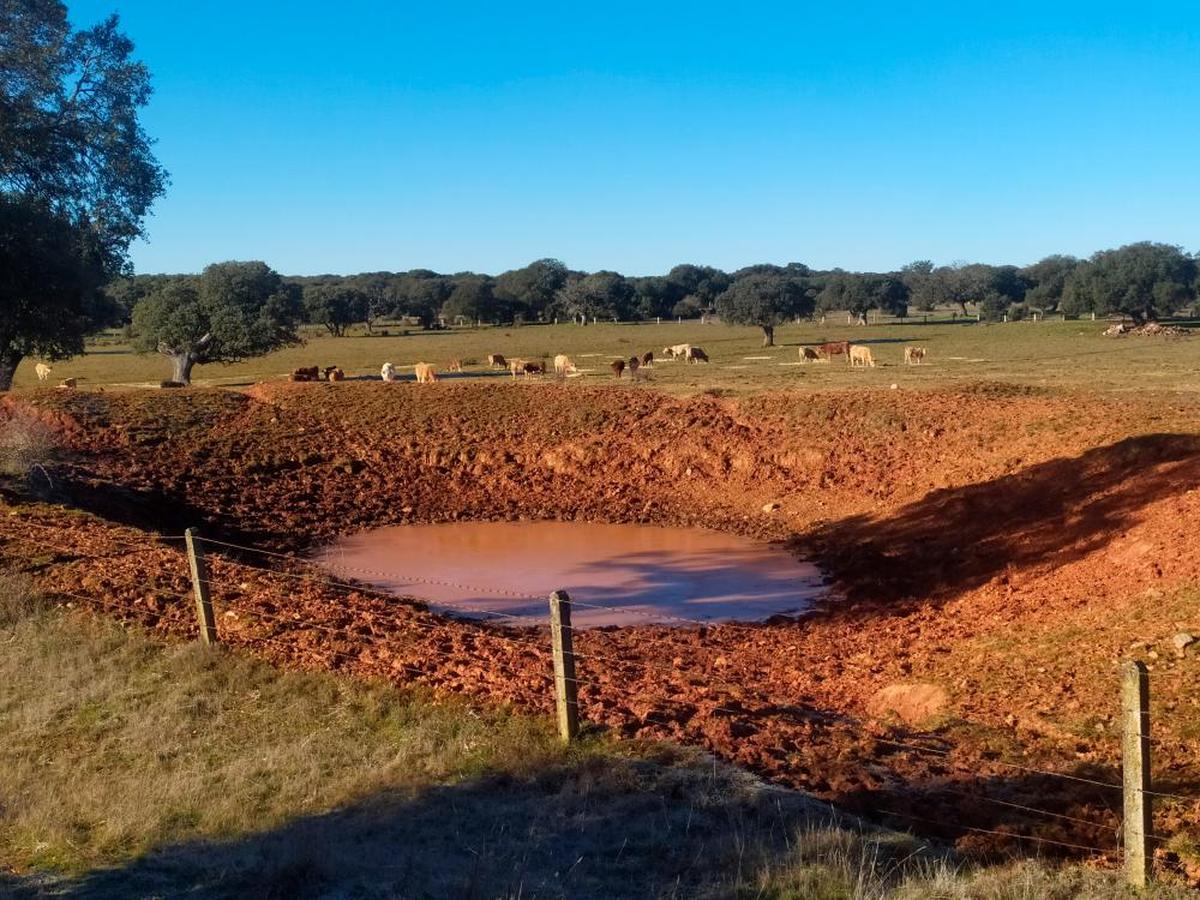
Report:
0,574,1184,900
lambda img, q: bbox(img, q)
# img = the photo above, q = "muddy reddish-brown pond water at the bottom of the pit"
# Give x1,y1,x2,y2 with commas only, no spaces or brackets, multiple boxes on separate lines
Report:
316,522,826,628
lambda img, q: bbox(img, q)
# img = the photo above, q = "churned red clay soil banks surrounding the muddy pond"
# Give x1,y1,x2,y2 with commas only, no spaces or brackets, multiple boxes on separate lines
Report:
0,384,1200,877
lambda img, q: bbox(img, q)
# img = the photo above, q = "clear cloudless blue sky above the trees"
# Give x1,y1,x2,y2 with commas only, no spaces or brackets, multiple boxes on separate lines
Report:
68,0,1200,275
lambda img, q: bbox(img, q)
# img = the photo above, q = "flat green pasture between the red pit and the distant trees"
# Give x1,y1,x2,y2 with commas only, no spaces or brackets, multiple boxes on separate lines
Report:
14,316,1200,392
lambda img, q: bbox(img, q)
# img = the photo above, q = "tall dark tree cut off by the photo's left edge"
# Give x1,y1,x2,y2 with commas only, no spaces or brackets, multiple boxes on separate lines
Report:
0,0,166,390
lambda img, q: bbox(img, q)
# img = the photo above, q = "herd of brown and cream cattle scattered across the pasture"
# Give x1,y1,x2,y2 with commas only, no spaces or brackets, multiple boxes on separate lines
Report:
288,341,925,384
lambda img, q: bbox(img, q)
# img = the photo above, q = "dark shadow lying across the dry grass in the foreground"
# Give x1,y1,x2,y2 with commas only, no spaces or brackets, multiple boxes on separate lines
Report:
0,760,864,900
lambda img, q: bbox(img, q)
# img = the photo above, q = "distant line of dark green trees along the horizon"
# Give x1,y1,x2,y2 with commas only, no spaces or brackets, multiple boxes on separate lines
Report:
109,242,1200,344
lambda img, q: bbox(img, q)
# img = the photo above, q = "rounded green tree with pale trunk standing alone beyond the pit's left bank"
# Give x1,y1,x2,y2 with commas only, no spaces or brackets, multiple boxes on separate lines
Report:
133,262,302,384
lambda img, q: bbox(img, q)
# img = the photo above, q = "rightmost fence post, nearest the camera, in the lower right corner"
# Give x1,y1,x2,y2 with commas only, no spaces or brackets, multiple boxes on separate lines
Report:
1121,661,1153,888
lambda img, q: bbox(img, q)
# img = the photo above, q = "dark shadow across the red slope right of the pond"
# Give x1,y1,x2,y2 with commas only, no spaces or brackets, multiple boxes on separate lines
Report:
792,434,1200,614
